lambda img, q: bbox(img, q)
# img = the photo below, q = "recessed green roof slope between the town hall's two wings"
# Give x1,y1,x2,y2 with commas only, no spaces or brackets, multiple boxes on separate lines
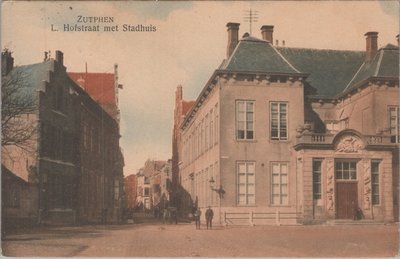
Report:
277,47,365,98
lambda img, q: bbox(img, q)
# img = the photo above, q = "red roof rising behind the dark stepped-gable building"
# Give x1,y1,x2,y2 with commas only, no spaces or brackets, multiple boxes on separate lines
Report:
68,72,116,105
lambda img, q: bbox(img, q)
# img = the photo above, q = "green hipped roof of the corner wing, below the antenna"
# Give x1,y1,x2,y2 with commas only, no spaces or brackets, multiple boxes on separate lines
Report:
220,37,299,74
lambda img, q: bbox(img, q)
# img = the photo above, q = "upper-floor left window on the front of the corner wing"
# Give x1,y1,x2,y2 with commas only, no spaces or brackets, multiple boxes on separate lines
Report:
236,101,254,139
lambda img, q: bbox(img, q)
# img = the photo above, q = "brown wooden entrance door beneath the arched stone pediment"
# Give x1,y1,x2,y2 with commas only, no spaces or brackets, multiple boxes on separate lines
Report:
336,182,358,219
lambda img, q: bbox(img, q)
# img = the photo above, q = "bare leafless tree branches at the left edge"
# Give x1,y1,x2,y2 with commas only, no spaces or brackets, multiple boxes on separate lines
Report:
1,69,37,153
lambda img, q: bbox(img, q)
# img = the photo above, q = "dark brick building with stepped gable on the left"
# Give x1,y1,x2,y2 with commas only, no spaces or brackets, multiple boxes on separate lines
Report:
2,51,123,223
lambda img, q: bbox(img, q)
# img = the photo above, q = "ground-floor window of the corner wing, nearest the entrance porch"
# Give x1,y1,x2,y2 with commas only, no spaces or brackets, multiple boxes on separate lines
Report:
271,162,288,205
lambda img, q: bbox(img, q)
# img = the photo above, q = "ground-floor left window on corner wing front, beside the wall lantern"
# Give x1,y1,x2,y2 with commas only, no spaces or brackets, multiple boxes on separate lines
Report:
237,162,255,205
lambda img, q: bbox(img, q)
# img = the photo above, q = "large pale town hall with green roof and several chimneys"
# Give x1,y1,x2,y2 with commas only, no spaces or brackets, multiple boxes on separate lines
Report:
173,23,400,224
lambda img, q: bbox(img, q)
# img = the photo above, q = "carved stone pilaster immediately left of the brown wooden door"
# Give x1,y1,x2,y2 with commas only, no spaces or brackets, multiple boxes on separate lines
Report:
325,158,336,219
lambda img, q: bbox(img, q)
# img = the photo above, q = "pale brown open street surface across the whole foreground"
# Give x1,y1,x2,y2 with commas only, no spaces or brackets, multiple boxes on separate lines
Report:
2,223,399,257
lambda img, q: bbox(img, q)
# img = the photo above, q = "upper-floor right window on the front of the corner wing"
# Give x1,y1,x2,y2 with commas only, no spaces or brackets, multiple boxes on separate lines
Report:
270,102,288,140
